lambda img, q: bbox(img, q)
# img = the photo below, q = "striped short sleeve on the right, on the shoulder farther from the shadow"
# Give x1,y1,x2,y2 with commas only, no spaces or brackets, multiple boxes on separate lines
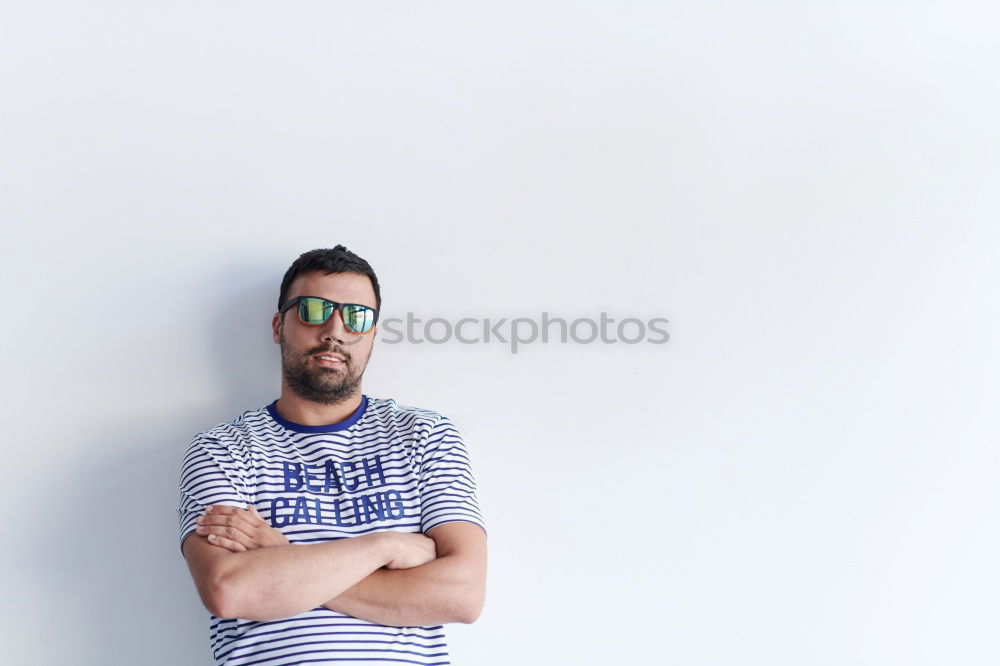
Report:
417,416,486,534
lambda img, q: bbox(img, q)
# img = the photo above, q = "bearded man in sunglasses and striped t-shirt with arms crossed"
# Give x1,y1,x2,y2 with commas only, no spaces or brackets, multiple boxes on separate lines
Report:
178,245,486,666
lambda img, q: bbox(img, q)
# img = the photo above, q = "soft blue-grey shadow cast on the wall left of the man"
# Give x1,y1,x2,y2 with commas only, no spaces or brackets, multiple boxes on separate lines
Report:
33,269,281,666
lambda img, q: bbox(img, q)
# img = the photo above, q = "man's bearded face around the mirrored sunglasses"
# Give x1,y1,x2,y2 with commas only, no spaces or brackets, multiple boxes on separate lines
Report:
271,272,377,405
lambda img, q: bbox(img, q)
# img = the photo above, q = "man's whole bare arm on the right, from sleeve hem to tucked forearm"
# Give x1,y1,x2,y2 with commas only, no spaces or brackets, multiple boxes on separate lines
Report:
323,521,486,627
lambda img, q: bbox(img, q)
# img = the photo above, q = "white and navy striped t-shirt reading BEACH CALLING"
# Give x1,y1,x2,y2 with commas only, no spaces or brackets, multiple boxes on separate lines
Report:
177,395,486,666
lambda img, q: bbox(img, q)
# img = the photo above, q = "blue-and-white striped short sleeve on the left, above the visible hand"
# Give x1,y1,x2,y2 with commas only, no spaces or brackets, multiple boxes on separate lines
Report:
177,437,252,554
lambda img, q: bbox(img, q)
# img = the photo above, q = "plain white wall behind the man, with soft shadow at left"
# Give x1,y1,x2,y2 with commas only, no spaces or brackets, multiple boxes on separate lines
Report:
0,1,1000,666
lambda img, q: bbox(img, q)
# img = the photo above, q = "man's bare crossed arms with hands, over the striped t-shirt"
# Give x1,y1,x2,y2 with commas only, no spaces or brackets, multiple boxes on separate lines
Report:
183,507,486,627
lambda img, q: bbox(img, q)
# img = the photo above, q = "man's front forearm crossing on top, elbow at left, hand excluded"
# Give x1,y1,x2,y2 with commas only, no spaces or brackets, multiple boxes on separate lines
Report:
182,528,392,621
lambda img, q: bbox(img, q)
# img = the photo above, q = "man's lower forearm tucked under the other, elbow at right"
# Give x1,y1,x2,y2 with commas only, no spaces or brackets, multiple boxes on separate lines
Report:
323,556,471,627
